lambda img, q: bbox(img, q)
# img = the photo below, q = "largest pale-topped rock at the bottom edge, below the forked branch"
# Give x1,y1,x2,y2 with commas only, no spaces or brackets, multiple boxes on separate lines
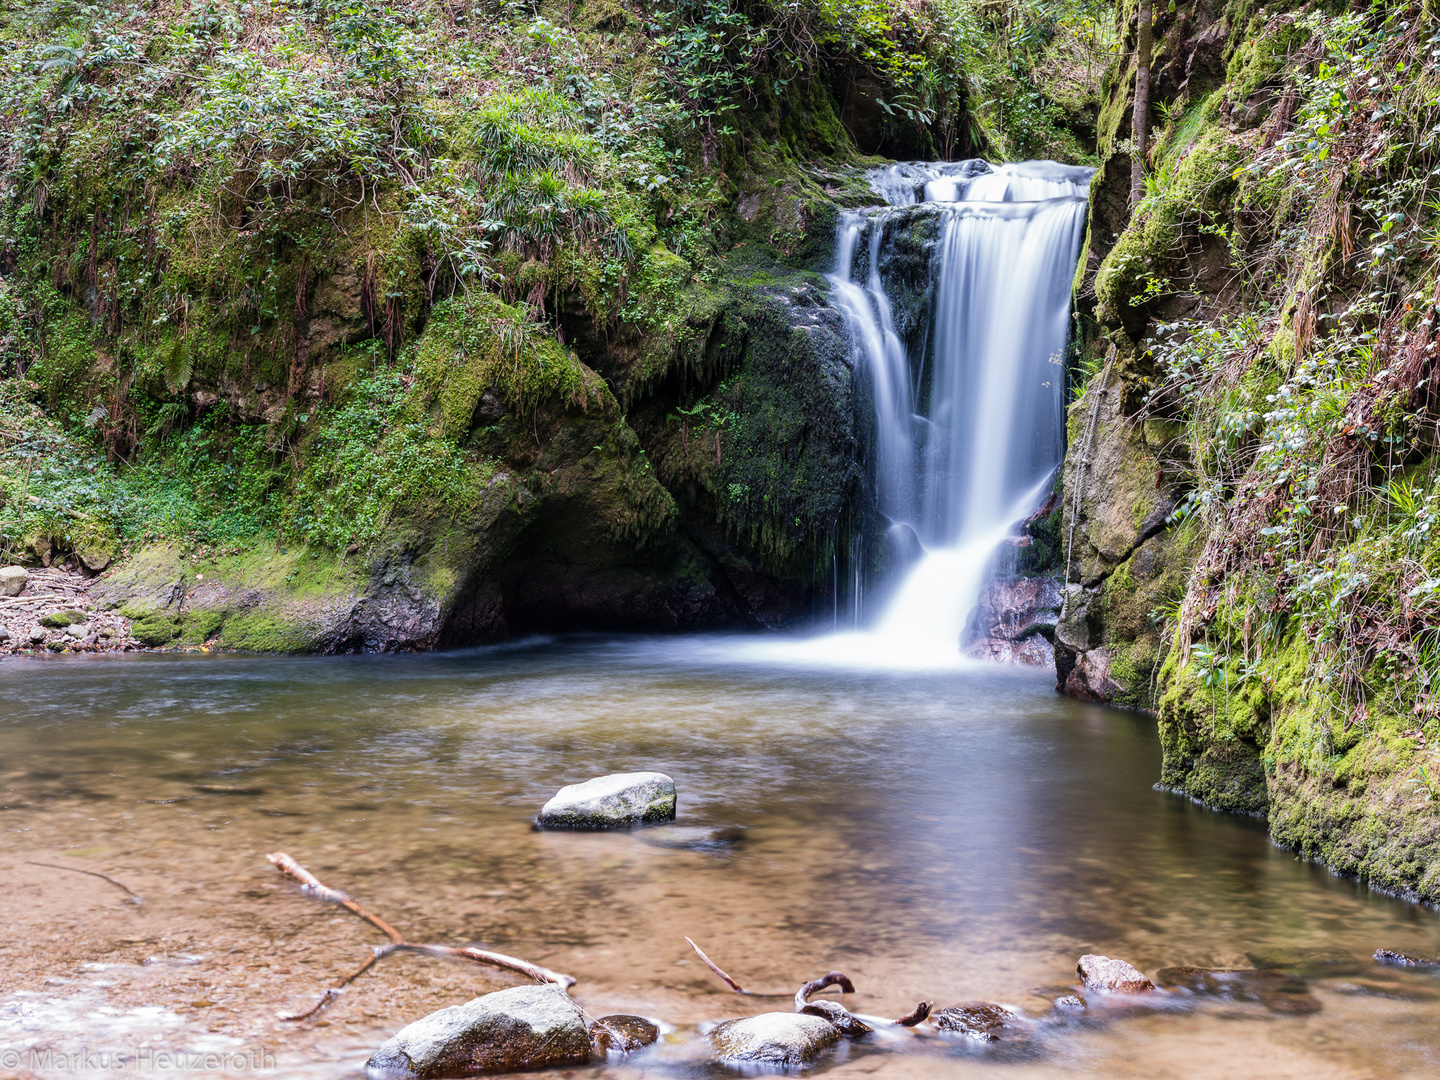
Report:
366,986,590,1077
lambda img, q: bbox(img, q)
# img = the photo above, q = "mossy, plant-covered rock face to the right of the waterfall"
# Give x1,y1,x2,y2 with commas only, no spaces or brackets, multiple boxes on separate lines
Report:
1056,3,1440,900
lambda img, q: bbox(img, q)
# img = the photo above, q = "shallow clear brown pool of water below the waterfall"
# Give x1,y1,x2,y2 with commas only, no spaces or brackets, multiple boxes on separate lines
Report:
0,638,1440,1080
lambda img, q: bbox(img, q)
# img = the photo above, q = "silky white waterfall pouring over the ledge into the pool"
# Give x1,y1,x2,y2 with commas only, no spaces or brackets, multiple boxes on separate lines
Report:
829,161,1092,665
